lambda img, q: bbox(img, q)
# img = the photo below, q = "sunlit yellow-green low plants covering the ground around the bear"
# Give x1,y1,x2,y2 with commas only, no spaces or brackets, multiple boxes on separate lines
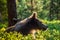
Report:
0,21,60,40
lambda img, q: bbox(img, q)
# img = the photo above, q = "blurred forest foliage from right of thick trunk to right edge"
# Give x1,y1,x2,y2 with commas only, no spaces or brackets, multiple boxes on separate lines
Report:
17,0,60,20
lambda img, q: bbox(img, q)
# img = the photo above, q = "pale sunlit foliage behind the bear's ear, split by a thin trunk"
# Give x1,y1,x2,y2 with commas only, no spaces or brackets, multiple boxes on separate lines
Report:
17,0,50,19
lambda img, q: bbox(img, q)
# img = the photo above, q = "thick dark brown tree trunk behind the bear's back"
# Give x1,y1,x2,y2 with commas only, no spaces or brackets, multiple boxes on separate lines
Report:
7,0,17,26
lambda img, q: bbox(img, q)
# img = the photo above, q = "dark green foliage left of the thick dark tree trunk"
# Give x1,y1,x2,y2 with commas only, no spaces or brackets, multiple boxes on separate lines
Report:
0,0,8,22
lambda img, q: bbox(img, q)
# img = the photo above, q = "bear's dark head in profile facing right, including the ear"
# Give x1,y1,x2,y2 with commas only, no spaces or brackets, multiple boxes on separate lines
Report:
26,12,48,30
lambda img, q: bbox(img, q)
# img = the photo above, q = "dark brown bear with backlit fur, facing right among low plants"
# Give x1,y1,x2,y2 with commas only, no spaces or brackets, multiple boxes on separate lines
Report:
6,12,47,39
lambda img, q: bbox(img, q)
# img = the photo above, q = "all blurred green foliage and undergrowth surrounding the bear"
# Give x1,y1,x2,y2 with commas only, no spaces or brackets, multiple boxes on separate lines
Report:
0,0,60,40
